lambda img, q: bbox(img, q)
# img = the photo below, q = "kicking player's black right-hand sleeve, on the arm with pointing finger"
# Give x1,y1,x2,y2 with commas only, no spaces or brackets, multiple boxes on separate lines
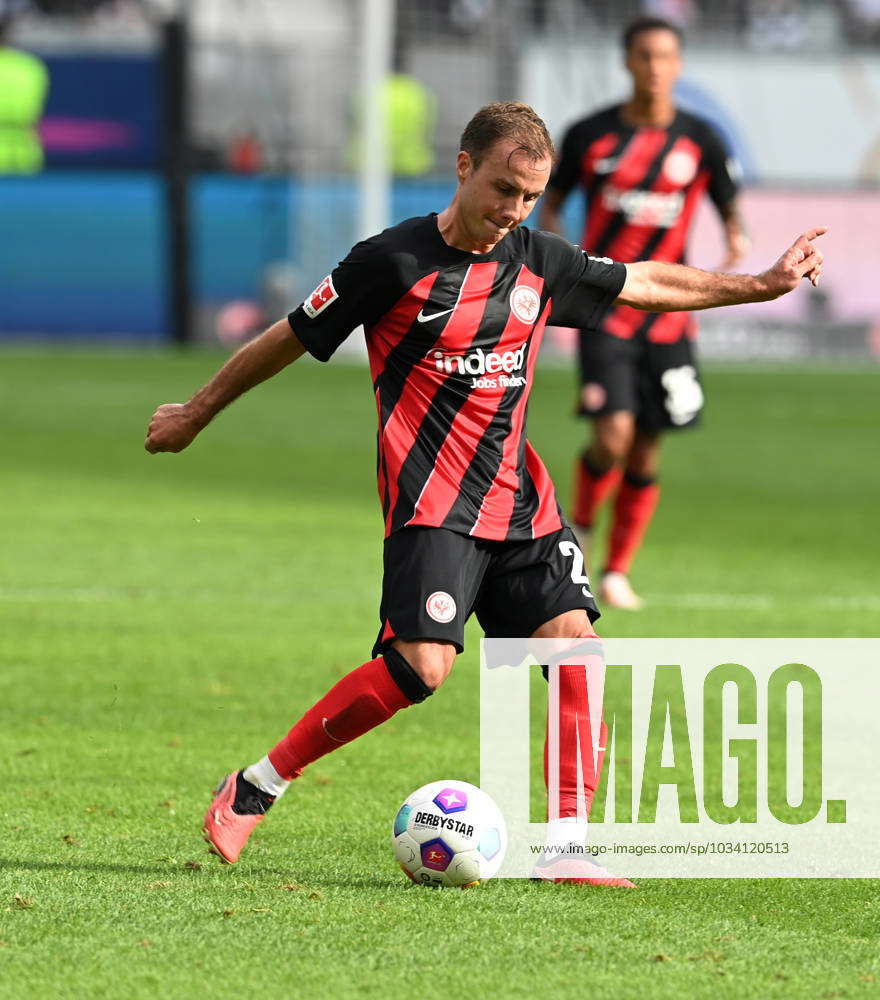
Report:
538,233,626,329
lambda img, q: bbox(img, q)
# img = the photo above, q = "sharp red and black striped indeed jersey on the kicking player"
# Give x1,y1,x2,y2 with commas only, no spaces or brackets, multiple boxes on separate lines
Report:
289,215,626,540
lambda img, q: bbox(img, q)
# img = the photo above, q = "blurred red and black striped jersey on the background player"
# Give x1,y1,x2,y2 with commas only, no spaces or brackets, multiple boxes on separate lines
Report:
549,105,739,343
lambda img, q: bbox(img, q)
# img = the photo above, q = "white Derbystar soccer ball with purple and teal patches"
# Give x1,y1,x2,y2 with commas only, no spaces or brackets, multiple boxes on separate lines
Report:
391,780,507,887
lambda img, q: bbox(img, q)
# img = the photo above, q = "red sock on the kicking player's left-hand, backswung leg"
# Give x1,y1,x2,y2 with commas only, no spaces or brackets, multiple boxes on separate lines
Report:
269,656,414,780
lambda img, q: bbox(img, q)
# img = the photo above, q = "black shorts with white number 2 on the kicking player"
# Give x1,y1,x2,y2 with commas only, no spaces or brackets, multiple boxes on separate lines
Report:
373,525,599,656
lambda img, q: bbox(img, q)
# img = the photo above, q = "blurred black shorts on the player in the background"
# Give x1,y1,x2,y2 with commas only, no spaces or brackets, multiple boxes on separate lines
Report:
578,330,703,433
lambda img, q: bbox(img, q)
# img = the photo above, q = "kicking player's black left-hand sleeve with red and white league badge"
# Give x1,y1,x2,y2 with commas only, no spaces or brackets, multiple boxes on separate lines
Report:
287,236,393,361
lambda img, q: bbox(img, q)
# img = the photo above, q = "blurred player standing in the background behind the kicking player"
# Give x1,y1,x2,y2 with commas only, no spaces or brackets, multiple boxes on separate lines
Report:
541,17,747,610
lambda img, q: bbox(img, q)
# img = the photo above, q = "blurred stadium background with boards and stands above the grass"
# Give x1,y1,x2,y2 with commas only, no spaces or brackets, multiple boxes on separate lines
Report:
0,0,880,364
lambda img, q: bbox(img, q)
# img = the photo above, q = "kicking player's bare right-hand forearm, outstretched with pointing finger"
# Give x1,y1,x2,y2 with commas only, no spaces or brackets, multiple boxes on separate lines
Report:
617,226,827,312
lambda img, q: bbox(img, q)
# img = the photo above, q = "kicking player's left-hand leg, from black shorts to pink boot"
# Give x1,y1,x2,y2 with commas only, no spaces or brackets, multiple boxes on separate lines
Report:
204,528,488,863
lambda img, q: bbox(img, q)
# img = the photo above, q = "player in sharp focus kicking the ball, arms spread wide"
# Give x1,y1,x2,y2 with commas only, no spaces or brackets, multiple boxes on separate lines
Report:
145,104,824,886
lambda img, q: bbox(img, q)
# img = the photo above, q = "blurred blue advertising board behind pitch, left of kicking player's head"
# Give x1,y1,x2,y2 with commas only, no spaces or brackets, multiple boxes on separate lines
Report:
0,170,451,339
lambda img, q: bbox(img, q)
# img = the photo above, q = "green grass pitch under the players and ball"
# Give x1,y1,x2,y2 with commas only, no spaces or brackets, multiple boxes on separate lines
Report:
0,347,880,1000
